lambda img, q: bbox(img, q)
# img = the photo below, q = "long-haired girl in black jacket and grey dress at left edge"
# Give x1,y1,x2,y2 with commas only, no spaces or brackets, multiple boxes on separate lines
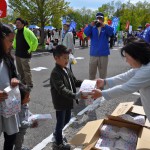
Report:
0,23,19,150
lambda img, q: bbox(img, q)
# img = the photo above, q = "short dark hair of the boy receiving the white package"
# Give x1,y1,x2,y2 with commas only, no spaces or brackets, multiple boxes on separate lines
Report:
53,45,70,57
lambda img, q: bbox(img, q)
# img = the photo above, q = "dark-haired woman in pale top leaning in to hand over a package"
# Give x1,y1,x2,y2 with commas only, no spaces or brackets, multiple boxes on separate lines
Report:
91,39,150,121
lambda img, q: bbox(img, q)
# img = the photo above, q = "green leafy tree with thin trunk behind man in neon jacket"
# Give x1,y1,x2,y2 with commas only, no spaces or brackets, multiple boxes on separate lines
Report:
9,0,69,44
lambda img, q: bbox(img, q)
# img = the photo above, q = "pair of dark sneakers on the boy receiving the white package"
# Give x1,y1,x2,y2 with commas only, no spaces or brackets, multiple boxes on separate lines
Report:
52,142,71,150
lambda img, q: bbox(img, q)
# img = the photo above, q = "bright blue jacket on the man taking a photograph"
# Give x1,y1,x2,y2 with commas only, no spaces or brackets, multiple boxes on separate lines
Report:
84,25,114,57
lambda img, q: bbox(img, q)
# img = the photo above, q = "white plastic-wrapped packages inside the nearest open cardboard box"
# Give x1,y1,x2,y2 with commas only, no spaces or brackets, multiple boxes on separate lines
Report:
95,125,138,150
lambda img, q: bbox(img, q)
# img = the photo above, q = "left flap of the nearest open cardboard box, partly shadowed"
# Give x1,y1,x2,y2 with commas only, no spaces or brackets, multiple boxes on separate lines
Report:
69,119,103,146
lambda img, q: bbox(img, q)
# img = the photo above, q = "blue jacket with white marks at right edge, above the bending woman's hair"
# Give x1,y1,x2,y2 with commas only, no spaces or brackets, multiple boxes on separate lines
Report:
138,27,150,44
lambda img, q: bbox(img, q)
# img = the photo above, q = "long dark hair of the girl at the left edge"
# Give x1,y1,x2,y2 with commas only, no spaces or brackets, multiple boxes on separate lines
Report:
0,23,14,59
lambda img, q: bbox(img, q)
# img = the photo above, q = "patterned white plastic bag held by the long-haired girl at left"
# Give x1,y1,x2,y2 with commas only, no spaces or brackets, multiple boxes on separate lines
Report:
0,86,21,118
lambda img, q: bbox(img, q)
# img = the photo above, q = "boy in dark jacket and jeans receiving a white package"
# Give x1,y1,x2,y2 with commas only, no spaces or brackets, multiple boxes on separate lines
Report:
50,45,82,150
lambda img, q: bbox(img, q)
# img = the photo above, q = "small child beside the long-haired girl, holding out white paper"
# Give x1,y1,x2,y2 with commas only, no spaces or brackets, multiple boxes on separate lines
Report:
14,85,38,150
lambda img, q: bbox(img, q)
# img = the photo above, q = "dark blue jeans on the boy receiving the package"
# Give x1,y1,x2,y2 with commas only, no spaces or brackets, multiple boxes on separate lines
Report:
54,109,71,145
